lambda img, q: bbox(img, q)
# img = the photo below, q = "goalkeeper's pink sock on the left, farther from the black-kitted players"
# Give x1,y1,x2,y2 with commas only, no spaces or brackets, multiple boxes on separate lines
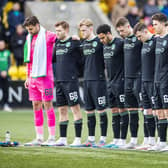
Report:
34,109,44,138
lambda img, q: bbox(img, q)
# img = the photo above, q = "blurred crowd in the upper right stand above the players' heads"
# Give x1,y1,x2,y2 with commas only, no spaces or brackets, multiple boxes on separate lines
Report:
100,0,168,33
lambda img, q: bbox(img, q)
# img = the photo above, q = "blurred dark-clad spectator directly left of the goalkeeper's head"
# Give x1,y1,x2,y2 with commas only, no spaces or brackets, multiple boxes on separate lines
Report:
11,25,26,66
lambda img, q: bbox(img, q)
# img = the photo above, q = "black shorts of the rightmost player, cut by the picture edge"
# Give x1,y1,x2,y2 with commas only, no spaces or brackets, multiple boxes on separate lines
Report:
154,81,168,109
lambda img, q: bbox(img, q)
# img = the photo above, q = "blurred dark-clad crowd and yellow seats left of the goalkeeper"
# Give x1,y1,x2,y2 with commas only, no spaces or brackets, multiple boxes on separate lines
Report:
0,0,26,80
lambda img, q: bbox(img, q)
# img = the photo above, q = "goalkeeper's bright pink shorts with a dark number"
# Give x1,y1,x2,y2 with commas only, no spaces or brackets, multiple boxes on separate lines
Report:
29,77,54,101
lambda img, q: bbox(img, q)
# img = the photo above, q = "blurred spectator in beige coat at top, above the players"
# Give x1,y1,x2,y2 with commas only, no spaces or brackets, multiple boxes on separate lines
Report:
111,0,129,24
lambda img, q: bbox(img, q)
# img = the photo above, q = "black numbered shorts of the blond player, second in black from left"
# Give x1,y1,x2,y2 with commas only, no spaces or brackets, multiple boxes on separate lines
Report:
84,80,107,111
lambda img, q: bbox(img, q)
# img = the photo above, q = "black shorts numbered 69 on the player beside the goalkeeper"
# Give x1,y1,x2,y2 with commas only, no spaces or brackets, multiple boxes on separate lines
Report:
56,81,79,107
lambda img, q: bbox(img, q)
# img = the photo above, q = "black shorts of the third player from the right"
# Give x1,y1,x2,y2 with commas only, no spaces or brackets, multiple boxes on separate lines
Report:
124,76,142,108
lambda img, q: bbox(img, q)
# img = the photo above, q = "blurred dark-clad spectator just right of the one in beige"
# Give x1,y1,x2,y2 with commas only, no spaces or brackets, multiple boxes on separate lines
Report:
126,6,140,27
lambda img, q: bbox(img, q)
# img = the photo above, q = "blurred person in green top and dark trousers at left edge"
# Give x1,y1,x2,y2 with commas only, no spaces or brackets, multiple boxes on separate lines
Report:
0,40,12,112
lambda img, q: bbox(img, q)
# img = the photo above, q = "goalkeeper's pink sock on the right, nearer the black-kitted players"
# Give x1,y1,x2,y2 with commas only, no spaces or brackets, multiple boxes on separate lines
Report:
47,108,55,136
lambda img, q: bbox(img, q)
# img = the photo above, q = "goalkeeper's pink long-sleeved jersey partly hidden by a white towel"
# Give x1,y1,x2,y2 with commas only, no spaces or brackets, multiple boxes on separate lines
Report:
27,31,56,80
